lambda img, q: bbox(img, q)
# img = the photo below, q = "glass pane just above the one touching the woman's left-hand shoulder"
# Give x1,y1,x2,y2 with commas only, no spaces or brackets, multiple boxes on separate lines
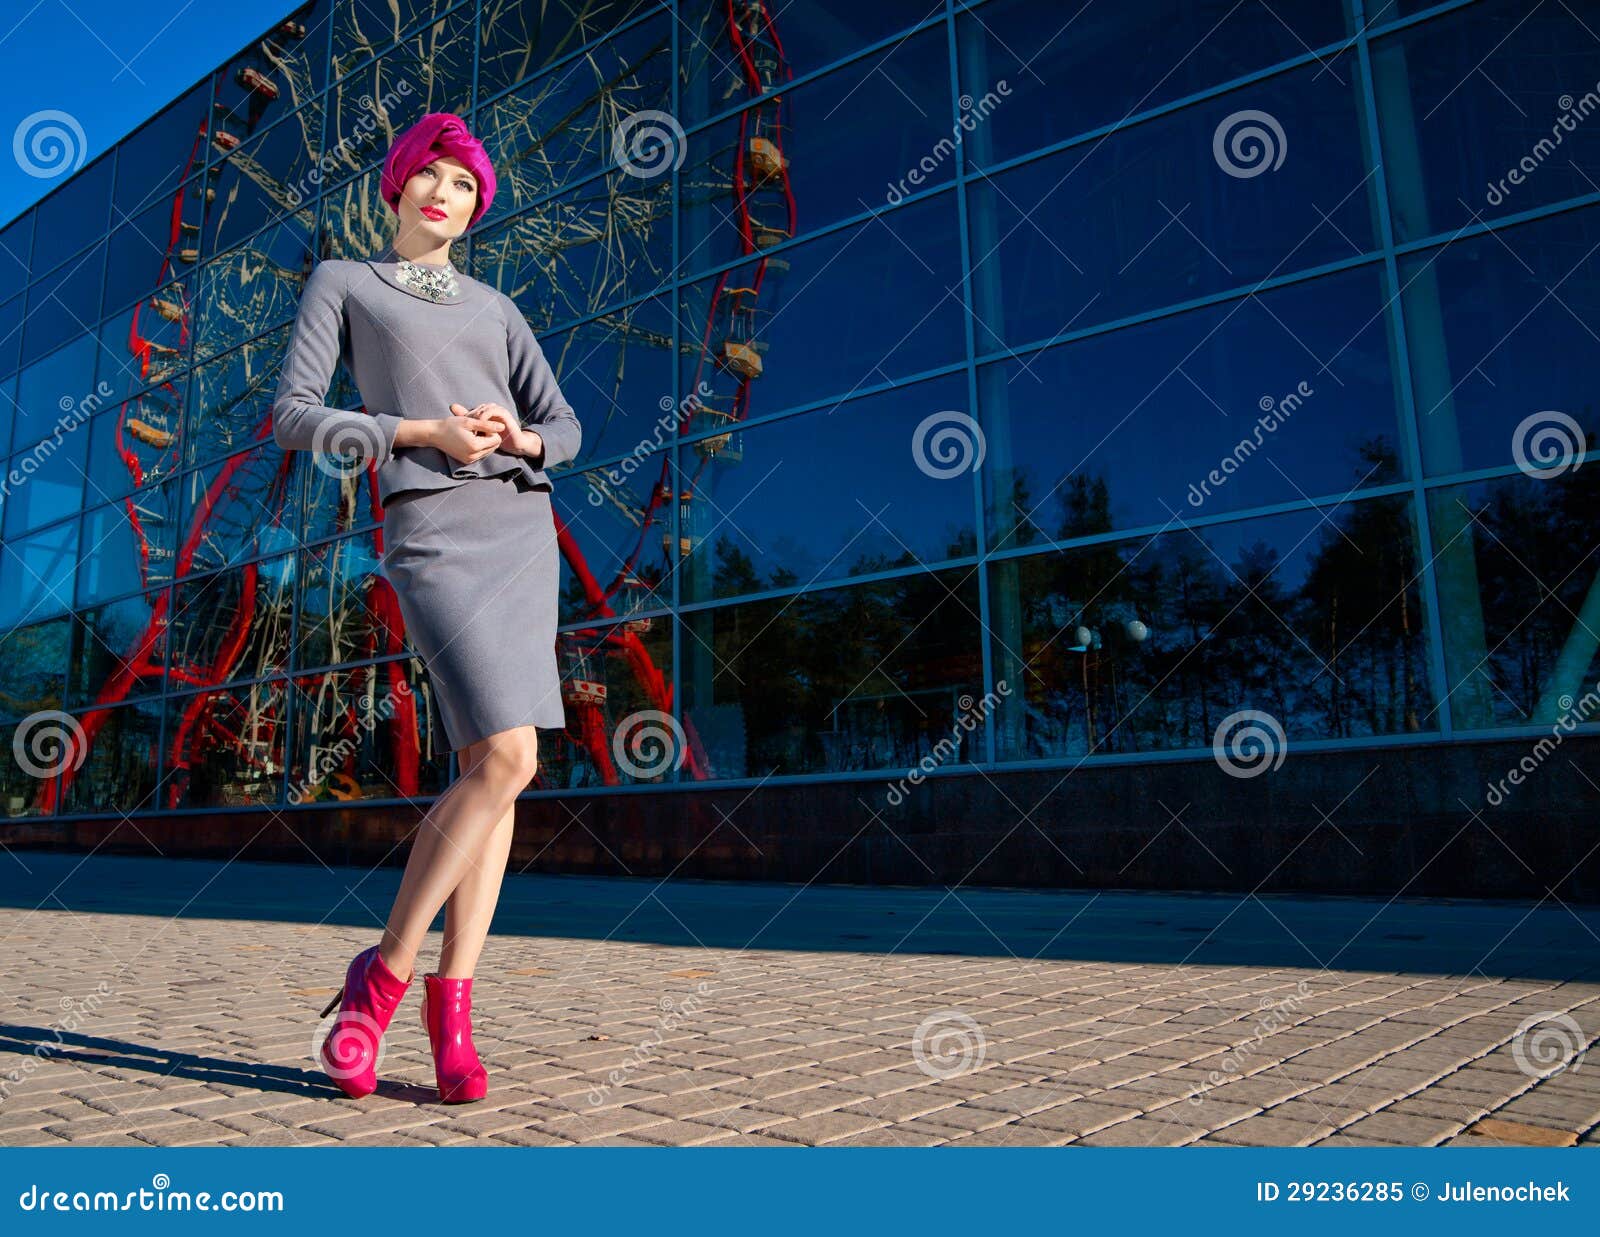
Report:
205,102,322,258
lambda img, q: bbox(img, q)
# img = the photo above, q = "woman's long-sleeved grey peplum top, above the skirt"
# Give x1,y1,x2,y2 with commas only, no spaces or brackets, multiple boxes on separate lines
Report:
272,245,582,502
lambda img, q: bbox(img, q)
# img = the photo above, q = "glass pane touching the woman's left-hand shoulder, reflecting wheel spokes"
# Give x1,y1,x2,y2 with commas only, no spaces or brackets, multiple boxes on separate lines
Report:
195,227,312,362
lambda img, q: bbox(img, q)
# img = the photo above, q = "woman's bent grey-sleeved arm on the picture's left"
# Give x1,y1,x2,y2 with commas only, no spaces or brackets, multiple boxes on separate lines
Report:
272,262,406,464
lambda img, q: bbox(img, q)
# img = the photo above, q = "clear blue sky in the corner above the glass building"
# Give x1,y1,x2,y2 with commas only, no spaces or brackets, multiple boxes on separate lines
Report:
0,0,302,224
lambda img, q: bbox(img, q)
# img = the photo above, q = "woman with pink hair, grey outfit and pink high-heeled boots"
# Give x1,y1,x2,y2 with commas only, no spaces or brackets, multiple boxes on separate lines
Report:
272,112,581,1104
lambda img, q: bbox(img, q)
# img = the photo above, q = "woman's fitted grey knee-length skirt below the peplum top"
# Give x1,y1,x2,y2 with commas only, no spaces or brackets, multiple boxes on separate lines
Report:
382,472,566,751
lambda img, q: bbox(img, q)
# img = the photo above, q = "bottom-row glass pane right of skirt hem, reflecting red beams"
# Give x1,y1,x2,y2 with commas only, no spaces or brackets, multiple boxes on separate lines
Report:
553,618,672,787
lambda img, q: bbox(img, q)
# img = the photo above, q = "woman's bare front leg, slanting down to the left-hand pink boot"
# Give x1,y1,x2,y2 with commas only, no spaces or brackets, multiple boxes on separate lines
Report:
378,727,539,978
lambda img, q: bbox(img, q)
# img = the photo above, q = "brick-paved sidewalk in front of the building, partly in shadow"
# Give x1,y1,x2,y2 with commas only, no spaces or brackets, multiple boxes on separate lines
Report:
0,851,1600,1147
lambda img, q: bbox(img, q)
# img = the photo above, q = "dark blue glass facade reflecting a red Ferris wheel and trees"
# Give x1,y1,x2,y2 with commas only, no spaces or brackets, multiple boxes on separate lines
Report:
0,0,1600,818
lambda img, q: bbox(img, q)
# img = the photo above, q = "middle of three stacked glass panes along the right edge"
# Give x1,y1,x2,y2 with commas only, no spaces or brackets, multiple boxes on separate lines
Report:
1400,206,1600,475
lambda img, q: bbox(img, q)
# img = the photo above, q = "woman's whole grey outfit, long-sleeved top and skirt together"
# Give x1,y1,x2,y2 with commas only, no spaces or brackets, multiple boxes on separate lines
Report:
272,246,581,749
